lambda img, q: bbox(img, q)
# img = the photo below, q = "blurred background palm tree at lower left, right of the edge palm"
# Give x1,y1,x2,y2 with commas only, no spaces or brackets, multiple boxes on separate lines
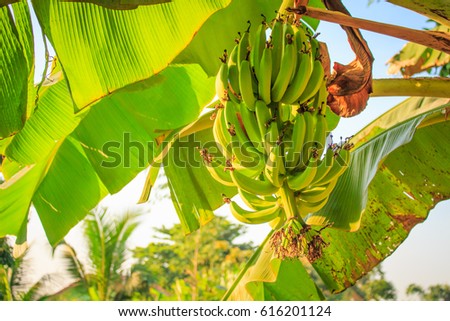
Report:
51,209,138,301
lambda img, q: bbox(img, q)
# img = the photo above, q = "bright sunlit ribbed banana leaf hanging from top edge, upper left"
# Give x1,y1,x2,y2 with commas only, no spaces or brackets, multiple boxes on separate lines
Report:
33,0,230,110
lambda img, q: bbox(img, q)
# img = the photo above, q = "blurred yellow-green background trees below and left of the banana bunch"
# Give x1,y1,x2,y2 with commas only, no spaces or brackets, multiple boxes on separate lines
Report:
132,217,252,300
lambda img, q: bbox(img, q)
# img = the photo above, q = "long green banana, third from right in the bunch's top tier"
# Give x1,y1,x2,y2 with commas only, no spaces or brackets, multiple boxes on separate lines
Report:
271,34,297,102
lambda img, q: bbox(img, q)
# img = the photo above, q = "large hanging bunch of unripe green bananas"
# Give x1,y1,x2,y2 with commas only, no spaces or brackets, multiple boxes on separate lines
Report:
202,17,350,240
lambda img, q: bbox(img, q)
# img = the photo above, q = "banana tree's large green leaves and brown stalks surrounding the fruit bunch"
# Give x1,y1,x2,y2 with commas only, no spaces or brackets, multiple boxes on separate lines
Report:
0,0,450,300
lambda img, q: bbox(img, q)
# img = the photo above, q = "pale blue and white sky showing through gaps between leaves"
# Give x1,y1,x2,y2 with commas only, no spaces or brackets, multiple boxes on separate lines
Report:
22,0,450,299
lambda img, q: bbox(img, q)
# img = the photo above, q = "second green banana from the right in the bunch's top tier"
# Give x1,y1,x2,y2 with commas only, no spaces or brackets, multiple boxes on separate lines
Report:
281,52,313,104
